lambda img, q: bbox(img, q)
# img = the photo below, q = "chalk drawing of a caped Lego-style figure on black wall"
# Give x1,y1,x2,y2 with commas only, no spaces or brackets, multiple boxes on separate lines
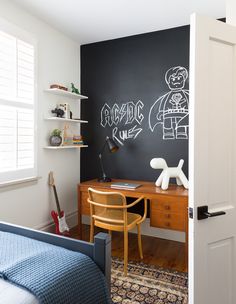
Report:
149,66,189,139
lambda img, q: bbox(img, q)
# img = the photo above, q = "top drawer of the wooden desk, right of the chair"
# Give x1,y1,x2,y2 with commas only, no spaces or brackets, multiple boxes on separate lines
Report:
151,196,188,213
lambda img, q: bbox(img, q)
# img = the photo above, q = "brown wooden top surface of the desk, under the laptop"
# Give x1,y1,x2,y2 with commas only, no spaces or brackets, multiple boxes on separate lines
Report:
79,179,188,197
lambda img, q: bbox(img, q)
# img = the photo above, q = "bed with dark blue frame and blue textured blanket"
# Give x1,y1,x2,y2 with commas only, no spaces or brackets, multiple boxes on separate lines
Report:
0,222,111,304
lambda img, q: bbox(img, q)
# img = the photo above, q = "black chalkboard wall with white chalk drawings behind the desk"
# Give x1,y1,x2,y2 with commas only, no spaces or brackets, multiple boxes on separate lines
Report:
81,26,189,181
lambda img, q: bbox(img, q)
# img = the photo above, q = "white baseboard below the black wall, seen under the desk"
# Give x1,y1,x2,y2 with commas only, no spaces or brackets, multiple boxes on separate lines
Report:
82,215,185,243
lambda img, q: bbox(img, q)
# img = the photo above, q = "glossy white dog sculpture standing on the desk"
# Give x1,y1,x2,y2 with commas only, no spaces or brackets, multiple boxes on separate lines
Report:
150,158,188,190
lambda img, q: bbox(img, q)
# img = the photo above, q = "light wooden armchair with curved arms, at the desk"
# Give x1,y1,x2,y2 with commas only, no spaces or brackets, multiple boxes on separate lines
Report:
88,188,147,276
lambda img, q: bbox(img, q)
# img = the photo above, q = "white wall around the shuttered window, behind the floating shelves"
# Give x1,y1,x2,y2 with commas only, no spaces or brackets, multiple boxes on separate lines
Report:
0,0,80,228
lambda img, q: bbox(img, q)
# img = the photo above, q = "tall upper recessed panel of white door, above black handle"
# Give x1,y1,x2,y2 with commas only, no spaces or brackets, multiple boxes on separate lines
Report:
207,39,234,207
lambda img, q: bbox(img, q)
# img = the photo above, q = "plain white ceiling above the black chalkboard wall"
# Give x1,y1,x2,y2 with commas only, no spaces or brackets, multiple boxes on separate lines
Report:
12,0,225,44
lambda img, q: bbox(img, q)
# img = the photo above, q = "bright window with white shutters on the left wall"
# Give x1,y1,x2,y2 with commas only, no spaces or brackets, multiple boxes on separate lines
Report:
0,25,37,183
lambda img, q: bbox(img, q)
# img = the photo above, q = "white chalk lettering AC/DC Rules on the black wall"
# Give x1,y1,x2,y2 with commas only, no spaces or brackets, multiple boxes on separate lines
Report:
100,100,144,146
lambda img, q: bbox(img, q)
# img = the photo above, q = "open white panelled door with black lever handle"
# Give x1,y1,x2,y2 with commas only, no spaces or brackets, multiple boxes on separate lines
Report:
189,15,236,304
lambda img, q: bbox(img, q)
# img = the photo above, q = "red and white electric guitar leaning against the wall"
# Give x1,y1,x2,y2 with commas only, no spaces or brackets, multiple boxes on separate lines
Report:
49,172,70,236
